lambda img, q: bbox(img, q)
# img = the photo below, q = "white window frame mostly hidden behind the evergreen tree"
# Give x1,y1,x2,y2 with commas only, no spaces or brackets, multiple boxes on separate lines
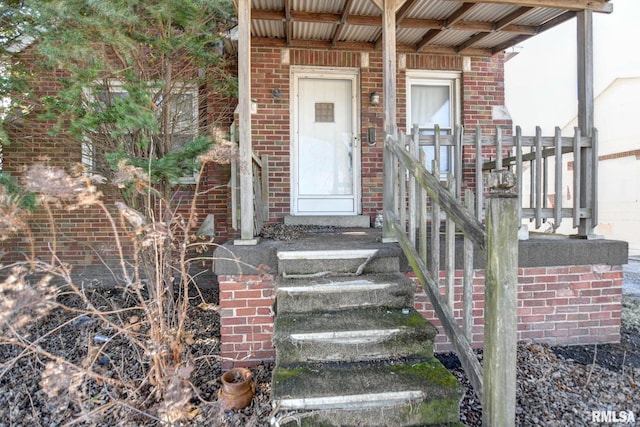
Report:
81,80,200,184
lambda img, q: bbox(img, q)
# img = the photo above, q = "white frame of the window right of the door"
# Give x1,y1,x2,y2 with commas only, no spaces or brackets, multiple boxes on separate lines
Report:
406,70,462,181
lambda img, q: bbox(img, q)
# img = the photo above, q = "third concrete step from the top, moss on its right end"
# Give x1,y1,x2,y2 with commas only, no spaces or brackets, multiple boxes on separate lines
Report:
273,307,437,366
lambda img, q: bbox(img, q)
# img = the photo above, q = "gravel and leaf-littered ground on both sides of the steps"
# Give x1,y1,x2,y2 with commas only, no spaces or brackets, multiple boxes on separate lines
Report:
0,280,640,427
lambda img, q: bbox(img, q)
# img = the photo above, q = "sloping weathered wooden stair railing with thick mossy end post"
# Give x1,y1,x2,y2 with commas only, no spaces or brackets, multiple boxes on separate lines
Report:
383,125,519,426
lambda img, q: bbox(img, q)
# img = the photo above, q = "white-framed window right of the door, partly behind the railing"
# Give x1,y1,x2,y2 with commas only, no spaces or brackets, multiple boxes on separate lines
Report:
407,71,460,180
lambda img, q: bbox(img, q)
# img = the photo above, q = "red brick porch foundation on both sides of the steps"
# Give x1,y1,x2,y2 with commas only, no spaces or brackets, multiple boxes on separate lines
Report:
218,265,623,367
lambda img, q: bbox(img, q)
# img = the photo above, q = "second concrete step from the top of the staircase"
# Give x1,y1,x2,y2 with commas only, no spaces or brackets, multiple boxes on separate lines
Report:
276,272,416,313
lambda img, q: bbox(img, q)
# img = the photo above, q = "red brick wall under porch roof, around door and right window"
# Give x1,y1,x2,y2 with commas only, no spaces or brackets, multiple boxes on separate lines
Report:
251,46,510,222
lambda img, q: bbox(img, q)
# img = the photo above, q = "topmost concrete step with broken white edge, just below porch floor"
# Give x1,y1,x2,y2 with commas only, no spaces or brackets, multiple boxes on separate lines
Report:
278,249,400,277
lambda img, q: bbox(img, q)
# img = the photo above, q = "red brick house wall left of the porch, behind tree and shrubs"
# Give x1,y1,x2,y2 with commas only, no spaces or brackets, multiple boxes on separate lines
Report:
0,48,236,265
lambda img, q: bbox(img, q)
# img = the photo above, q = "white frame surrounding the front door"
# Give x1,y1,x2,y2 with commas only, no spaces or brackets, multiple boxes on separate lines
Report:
289,66,362,216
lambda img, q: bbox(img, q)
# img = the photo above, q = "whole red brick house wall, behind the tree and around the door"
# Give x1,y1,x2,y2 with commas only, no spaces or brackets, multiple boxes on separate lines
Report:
4,46,508,259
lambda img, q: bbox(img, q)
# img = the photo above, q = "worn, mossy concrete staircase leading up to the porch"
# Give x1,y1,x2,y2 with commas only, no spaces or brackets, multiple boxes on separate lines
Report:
272,249,462,427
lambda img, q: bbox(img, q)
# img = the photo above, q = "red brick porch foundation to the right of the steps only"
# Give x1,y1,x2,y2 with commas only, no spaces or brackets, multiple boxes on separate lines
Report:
414,265,622,352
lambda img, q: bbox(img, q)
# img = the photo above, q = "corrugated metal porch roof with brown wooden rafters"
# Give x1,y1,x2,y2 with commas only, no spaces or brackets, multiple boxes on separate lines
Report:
239,0,613,56
